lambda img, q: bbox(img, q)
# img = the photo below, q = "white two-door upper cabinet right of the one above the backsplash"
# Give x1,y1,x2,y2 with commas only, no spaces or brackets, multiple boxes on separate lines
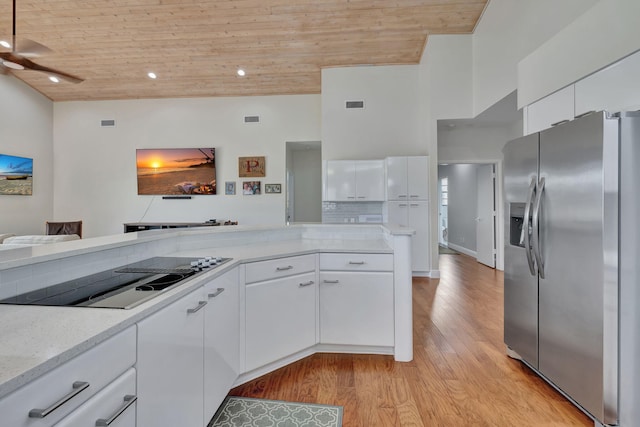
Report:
386,156,429,201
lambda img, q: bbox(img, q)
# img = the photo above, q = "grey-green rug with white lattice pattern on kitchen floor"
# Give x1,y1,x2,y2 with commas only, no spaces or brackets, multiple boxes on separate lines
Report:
208,396,342,427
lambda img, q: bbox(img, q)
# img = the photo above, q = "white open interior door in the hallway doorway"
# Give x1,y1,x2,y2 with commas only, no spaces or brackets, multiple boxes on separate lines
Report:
476,165,496,268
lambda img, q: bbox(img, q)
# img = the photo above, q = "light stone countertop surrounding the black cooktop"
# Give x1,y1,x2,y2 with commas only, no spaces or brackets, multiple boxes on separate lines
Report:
0,227,413,398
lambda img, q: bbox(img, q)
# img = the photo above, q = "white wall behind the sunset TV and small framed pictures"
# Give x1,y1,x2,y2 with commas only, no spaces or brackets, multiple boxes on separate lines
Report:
53,95,320,237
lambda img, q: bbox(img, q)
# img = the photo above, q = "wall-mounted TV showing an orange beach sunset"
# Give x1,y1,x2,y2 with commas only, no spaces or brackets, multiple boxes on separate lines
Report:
136,148,216,196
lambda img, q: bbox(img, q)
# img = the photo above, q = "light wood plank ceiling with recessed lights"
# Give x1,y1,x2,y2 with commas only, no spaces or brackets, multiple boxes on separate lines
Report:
0,0,488,101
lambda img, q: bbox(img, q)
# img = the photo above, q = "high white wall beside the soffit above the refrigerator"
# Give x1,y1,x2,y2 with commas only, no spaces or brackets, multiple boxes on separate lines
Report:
473,0,596,115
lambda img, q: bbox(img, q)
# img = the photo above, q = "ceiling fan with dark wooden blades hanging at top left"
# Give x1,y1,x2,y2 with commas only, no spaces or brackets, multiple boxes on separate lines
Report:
0,0,84,83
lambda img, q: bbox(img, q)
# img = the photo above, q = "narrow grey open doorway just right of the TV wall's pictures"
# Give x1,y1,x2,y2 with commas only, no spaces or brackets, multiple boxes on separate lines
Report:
285,141,322,223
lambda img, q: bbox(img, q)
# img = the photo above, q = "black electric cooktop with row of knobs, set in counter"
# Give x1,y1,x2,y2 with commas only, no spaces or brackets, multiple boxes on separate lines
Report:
0,257,230,309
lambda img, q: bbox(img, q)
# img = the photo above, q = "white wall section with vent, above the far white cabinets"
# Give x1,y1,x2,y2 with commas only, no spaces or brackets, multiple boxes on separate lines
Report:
322,65,427,160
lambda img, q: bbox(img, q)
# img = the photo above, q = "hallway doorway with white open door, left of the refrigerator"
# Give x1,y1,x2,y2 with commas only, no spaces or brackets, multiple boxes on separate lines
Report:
438,163,497,268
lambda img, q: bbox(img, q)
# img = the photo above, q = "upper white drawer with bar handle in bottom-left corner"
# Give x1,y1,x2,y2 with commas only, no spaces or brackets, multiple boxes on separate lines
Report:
0,326,136,427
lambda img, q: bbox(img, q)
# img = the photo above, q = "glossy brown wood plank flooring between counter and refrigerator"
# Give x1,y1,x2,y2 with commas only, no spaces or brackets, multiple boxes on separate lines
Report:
229,255,593,427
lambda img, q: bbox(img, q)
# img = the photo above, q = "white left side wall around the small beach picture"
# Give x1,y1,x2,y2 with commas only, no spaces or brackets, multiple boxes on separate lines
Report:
0,75,53,234
